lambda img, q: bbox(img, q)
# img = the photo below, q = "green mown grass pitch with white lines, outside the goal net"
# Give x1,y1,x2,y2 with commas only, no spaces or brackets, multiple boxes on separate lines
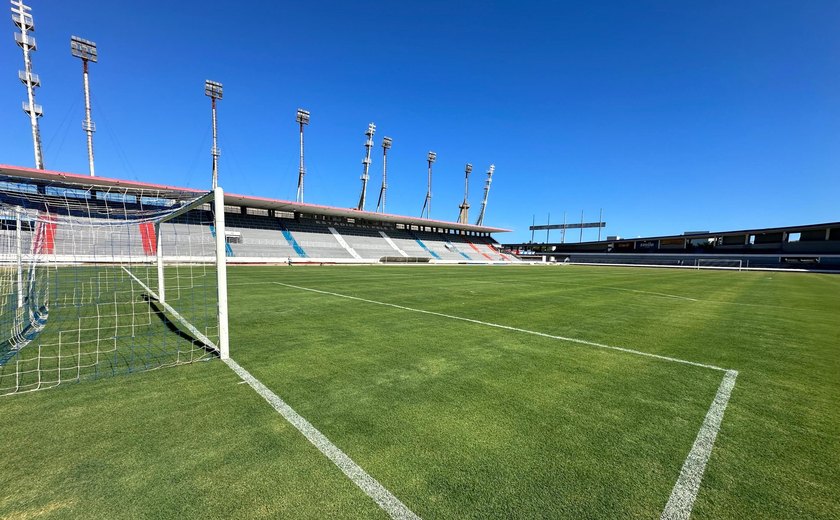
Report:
0,266,840,519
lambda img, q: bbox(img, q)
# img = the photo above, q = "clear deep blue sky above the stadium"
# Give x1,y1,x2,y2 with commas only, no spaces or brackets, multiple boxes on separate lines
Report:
0,0,840,241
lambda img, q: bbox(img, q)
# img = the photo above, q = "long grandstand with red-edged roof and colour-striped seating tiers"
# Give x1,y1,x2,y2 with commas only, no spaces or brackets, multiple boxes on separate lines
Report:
0,167,507,263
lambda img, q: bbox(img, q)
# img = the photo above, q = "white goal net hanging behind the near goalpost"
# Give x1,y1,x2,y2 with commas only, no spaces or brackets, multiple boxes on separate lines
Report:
0,177,219,395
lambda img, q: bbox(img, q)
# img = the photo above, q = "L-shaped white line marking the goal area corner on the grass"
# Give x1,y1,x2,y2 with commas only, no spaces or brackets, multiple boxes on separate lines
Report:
272,282,738,520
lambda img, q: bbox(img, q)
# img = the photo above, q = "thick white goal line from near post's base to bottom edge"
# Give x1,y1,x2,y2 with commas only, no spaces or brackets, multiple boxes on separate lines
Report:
223,359,420,520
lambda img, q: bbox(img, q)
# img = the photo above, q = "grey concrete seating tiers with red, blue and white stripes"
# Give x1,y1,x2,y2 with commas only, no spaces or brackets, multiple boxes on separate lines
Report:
21,208,518,263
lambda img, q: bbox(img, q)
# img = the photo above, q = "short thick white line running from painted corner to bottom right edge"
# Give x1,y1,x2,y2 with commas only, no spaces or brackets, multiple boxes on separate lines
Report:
661,370,738,520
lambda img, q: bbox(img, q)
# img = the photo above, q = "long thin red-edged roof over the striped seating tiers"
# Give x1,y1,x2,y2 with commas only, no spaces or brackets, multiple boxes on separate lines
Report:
0,164,510,233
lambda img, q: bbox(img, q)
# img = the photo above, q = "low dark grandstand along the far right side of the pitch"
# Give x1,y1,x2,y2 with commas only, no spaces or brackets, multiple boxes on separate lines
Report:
502,222,840,271
